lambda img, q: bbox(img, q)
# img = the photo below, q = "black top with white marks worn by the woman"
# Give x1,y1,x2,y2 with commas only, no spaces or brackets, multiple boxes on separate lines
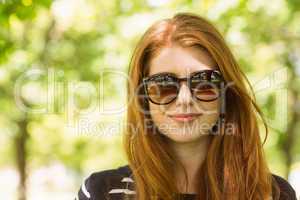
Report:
76,165,296,200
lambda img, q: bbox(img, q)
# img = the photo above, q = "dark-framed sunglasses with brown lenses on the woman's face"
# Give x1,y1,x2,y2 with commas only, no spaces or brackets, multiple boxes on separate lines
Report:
143,70,224,105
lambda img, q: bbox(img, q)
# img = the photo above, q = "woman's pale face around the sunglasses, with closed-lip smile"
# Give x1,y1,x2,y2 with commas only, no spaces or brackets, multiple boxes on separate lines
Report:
148,46,220,143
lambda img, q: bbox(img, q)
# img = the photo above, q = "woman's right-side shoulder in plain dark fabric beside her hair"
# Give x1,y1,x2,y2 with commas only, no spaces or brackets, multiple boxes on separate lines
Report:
272,174,297,200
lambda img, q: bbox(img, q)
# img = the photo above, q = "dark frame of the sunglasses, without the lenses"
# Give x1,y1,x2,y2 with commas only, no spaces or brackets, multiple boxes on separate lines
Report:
143,69,224,105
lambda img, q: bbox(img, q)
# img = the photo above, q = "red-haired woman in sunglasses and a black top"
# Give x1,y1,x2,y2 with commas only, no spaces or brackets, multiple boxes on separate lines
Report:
78,13,296,200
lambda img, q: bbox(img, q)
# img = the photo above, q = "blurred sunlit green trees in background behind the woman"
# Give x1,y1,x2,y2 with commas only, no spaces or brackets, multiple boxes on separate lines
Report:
0,0,300,200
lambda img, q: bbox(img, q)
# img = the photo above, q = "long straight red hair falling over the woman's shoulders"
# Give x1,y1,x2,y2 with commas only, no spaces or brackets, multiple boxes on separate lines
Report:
124,13,279,200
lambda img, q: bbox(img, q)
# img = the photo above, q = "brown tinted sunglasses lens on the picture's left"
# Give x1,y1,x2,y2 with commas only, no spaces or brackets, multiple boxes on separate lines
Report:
147,77,178,104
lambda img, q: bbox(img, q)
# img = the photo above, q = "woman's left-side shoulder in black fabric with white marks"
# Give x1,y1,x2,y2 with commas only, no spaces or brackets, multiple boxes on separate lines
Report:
78,165,134,200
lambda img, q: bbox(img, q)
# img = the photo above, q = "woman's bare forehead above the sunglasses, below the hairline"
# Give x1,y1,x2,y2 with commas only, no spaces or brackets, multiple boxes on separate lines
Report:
149,46,217,77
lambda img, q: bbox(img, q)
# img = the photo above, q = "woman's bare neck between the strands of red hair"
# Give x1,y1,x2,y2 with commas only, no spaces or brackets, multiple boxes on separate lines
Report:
171,135,210,193
